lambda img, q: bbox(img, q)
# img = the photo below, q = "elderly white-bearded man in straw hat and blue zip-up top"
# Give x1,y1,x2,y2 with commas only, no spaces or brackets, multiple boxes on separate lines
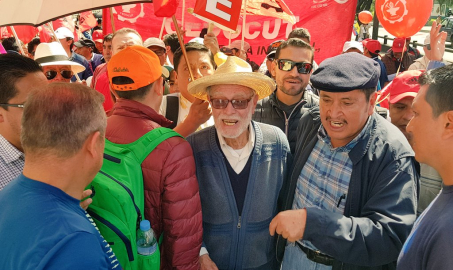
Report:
187,56,291,269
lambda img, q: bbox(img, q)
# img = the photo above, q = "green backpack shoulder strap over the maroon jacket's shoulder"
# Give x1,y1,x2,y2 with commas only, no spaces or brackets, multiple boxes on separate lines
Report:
128,127,184,164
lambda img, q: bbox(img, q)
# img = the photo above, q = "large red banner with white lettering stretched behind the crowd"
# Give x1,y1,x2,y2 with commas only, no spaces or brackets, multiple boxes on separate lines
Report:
103,0,357,64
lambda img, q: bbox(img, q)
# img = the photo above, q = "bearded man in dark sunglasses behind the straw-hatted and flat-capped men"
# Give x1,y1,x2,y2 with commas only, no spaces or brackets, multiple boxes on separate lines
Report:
253,38,318,153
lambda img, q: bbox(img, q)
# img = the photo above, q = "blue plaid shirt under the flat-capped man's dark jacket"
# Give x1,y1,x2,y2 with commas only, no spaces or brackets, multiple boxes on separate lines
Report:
293,118,370,250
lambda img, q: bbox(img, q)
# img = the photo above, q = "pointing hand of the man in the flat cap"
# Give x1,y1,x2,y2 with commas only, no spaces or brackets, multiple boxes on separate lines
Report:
269,209,307,242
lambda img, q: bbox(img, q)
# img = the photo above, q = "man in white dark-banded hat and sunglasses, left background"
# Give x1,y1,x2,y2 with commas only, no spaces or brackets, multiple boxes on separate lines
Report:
35,42,85,82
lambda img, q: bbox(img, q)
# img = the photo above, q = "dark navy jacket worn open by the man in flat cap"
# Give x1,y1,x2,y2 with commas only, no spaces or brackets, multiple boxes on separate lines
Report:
277,107,420,270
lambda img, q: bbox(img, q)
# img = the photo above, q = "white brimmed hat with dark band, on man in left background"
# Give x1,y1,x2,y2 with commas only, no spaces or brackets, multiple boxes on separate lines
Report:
35,42,85,73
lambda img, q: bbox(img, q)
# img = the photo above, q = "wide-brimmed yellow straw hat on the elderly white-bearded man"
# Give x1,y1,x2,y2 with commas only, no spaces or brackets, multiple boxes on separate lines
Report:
188,56,275,100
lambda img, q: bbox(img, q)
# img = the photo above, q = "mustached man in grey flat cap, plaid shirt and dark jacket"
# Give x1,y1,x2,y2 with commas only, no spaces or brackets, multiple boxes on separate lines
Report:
269,53,419,270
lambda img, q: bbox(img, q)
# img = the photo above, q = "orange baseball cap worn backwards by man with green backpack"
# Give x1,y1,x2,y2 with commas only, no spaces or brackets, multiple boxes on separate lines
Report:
107,46,164,91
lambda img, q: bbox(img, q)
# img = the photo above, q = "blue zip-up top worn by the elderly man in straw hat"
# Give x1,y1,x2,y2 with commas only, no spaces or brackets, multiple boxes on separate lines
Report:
187,121,291,270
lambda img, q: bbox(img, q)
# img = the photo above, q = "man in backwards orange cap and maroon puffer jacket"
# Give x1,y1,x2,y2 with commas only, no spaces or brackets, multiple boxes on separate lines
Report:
105,45,202,270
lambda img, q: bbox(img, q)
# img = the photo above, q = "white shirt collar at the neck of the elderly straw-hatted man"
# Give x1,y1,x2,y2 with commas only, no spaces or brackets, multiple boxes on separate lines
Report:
217,124,255,174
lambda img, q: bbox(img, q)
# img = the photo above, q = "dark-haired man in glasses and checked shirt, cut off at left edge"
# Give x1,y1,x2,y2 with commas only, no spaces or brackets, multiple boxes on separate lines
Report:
0,54,47,190
